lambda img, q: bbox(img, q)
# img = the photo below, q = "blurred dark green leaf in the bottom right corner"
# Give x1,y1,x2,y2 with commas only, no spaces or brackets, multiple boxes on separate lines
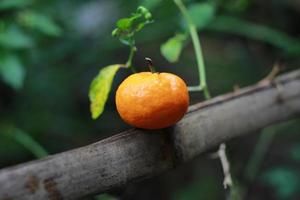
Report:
262,167,300,199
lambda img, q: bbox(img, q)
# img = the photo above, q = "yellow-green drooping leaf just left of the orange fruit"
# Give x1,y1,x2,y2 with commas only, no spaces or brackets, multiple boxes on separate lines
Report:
89,64,121,119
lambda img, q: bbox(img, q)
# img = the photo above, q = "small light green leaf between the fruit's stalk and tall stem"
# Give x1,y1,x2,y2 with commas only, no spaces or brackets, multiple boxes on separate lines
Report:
160,34,187,63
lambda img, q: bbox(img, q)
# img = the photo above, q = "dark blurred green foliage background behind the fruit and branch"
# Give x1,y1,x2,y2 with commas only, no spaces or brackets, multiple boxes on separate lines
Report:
0,0,300,200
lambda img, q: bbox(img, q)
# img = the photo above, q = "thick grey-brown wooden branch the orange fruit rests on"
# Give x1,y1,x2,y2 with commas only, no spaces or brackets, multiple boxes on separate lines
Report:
0,70,300,200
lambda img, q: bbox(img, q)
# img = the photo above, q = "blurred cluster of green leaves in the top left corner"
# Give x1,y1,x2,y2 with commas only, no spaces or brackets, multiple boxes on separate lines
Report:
0,0,61,89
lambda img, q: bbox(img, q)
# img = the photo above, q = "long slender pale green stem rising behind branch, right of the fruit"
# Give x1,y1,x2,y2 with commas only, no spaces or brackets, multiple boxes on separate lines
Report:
174,0,211,99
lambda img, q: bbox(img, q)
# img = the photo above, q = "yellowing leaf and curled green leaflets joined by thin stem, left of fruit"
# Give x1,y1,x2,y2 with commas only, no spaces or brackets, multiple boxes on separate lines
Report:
89,6,153,119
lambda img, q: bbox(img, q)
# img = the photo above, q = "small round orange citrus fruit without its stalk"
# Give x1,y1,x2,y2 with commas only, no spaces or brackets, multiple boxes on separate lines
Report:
116,72,189,129
